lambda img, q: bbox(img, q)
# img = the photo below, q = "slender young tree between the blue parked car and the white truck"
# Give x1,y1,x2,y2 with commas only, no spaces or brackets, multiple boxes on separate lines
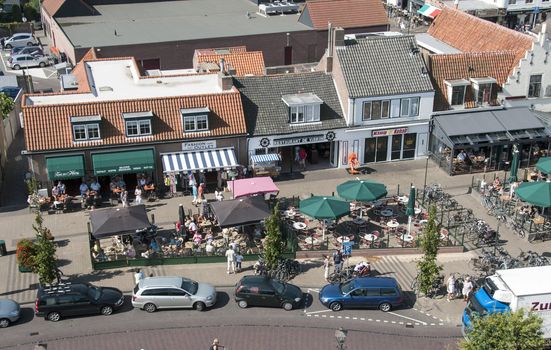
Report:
417,205,442,296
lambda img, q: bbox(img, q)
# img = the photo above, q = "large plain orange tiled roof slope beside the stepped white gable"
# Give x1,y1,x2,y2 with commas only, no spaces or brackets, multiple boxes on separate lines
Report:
428,7,533,66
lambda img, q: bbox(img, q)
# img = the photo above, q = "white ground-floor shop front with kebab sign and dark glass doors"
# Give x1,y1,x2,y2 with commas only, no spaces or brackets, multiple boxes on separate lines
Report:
341,123,428,165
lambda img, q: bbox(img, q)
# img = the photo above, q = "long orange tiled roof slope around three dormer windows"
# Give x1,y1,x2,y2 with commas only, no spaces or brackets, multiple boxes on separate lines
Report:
22,90,246,151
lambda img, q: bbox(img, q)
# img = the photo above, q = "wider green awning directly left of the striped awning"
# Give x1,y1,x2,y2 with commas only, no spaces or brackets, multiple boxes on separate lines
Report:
92,149,155,176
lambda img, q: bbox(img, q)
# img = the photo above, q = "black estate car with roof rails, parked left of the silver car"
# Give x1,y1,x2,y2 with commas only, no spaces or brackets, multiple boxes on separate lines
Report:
35,283,124,322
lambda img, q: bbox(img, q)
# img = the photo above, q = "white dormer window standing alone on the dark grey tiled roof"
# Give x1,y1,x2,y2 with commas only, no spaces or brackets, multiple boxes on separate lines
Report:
281,93,323,124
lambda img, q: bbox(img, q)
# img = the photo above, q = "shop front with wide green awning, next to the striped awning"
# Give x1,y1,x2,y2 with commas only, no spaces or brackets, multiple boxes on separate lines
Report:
91,148,155,193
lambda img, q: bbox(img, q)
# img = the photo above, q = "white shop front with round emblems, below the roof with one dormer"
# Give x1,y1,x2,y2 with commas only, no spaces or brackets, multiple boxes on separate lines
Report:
249,130,340,174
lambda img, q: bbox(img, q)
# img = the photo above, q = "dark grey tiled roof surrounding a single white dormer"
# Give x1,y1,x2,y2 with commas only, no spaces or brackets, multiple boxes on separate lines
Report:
234,72,346,136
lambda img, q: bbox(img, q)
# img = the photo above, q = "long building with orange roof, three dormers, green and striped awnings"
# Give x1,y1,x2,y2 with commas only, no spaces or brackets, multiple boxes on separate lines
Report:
22,58,246,194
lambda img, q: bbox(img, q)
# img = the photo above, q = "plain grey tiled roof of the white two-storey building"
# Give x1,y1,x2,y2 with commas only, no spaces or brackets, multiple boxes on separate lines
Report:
337,35,434,98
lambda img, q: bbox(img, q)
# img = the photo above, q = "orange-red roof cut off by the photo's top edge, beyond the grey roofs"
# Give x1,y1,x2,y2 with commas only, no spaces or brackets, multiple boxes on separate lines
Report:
299,0,388,30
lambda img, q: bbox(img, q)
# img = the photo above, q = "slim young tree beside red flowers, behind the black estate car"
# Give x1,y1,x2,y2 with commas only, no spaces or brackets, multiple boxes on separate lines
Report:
31,213,58,285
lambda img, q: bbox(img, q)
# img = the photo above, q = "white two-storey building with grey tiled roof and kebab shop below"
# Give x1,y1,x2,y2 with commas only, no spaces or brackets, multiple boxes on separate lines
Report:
319,29,434,167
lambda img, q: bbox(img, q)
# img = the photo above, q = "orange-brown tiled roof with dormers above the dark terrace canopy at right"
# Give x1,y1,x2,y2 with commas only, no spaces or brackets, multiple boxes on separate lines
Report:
429,51,515,110
